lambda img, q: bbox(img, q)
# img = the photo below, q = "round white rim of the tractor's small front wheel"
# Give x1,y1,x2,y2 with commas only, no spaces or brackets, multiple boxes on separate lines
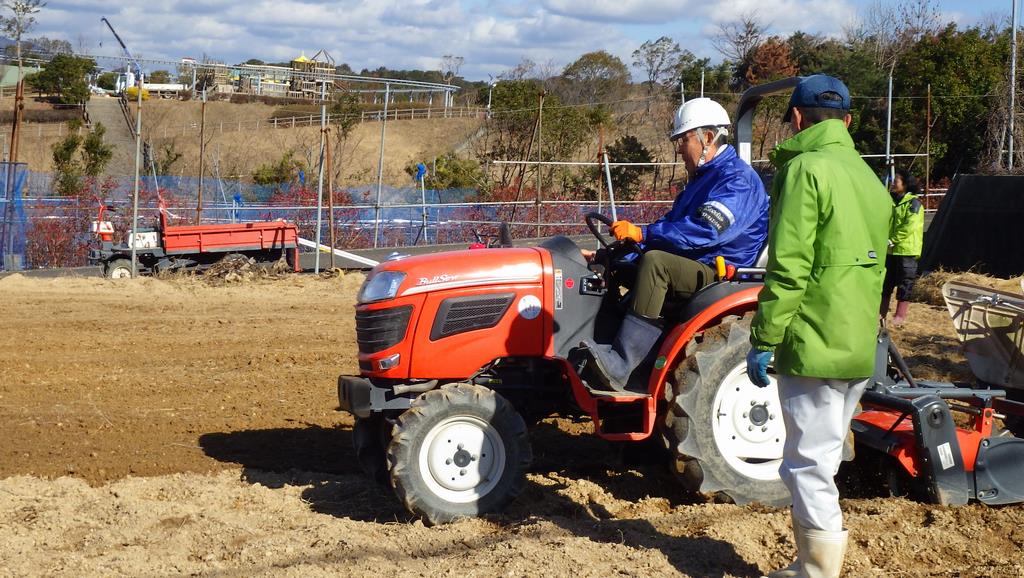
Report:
419,415,505,503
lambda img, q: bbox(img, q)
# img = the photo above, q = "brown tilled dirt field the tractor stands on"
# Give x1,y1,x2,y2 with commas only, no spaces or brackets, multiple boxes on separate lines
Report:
0,275,1024,576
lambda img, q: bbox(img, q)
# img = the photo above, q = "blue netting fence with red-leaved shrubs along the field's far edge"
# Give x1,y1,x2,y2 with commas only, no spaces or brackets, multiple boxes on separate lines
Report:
0,161,945,269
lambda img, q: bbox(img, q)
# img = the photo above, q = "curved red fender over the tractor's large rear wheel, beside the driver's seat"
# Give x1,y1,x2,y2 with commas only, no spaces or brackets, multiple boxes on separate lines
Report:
647,284,762,400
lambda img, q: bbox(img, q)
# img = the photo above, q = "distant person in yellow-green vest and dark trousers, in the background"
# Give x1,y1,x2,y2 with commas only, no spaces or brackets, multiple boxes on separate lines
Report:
879,169,925,327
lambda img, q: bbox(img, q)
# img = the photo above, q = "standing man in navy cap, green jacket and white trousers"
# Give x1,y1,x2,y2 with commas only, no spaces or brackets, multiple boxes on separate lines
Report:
746,75,892,577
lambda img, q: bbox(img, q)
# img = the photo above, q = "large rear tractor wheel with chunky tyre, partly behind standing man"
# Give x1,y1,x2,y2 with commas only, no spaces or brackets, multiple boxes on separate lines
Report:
664,314,791,506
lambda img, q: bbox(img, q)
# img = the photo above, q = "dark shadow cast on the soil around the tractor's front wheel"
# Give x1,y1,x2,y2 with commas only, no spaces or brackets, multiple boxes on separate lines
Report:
200,422,758,576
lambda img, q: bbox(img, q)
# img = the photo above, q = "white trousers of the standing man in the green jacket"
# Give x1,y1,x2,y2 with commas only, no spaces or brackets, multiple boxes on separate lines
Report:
778,375,868,532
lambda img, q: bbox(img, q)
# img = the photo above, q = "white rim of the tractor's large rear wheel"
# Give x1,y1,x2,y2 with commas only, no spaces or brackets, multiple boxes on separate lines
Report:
712,362,785,481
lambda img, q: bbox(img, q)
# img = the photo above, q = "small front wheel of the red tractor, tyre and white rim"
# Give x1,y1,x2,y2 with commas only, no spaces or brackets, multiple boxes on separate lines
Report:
387,383,532,524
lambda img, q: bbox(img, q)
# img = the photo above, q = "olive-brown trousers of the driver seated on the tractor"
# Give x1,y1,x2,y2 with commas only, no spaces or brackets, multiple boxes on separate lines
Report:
633,251,715,319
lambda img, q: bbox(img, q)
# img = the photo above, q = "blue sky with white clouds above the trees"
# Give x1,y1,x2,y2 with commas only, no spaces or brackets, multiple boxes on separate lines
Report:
30,0,1011,80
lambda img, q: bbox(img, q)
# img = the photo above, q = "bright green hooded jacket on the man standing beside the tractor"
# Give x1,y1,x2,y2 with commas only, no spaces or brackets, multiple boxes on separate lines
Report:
751,120,893,379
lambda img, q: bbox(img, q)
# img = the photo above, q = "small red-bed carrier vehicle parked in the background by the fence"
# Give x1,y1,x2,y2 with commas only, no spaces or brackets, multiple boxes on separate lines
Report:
89,205,299,279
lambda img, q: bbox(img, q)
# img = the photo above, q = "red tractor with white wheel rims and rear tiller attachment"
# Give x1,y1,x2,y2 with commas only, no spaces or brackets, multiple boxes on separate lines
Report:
338,79,1024,524
